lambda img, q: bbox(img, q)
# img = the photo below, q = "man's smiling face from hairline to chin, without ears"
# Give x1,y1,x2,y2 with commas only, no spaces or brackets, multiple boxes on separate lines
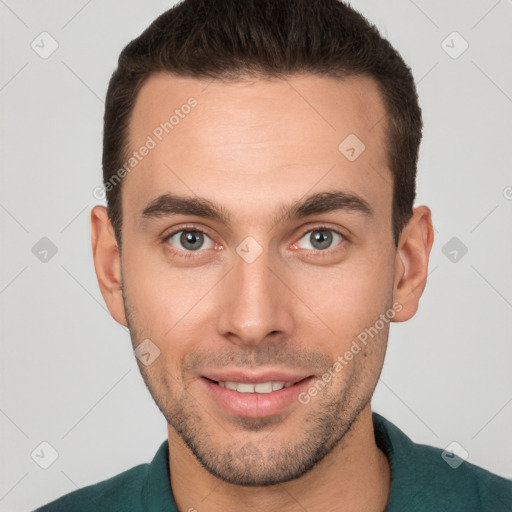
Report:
97,74,424,485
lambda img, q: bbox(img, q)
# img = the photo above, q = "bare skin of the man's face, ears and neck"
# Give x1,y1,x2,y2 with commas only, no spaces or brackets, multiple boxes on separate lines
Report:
91,74,433,512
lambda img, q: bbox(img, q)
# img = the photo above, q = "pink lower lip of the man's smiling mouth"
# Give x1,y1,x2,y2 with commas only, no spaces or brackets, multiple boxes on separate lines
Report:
201,377,313,418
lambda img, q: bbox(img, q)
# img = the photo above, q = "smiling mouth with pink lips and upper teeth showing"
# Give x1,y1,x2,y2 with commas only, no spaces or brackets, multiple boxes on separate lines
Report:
200,374,315,418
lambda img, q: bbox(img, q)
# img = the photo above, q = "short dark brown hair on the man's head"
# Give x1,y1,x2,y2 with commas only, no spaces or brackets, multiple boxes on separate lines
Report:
103,0,422,247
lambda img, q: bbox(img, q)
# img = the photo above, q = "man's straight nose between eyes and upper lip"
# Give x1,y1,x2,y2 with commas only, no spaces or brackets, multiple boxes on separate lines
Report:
217,247,294,348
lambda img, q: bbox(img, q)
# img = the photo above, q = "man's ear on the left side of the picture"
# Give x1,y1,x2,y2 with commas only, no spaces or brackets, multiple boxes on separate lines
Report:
91,206,128,327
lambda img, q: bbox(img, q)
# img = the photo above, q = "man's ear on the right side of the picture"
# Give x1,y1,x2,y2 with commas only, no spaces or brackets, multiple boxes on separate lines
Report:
393,206,434,322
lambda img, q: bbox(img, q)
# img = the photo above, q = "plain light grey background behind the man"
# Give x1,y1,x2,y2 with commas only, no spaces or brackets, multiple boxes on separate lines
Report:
0,0,512,512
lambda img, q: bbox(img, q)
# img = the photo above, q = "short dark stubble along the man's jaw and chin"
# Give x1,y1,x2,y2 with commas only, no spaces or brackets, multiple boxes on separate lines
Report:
125,288,386,487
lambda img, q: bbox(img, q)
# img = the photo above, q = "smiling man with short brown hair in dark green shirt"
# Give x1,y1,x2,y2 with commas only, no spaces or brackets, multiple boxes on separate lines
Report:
34,0,512,512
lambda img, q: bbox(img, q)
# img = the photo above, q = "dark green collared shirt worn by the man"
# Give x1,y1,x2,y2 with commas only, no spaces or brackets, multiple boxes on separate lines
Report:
36,412,512,512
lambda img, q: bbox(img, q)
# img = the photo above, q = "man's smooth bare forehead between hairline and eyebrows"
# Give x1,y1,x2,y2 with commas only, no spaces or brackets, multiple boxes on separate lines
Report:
123,73,392,226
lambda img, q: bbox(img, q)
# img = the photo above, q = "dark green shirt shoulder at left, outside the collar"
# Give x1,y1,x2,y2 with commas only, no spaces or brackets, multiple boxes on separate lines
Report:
34,464,149,512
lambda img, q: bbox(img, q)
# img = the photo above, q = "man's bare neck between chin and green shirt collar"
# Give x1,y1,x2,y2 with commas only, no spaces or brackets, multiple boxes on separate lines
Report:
168,404,391,512
